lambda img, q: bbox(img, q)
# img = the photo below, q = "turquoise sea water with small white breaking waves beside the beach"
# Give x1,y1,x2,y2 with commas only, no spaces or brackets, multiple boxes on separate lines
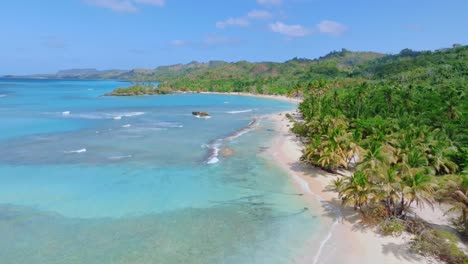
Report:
0,79,321,264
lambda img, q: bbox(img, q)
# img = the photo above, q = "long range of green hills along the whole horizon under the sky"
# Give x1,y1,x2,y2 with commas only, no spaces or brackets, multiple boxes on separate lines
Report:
4,45,468,93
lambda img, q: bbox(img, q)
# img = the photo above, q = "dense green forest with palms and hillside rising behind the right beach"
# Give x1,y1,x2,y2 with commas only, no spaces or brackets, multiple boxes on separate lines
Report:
292,46,468,263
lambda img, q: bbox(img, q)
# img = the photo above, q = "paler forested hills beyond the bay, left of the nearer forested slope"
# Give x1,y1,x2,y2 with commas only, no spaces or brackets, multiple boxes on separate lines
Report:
138,50,384,95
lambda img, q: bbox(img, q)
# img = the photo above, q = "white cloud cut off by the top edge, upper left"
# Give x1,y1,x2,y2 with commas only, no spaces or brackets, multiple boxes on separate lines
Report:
84,0,166,13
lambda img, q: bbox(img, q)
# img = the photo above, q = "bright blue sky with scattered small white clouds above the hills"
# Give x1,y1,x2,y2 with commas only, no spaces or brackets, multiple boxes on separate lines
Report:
0,0,468,74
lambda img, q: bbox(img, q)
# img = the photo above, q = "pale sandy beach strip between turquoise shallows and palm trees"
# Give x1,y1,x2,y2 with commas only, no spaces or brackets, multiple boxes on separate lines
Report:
269,112,433,264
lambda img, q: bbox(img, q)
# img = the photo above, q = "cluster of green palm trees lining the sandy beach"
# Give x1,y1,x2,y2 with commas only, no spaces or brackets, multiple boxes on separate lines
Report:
292,79,468,233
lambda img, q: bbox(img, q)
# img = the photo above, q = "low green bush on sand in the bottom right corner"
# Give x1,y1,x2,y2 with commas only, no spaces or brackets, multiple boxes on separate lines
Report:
411,229,468,264
